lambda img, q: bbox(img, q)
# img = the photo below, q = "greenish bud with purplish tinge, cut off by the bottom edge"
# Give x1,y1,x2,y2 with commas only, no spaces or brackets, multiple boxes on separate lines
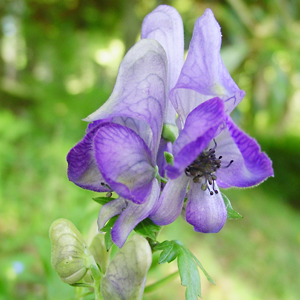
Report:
101,235,152,300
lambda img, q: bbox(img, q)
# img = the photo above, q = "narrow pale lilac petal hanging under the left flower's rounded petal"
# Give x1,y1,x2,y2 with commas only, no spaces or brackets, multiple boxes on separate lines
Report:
111,178,160,248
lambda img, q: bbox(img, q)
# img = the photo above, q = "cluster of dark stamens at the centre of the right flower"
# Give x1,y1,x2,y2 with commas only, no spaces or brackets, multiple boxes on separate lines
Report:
185,139,233,195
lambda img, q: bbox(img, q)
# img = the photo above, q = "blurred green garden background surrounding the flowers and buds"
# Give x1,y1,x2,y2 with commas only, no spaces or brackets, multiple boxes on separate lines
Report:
0,0,300,300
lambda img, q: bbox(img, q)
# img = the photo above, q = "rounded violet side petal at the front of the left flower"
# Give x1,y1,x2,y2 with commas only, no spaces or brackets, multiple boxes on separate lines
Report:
94,123,155,203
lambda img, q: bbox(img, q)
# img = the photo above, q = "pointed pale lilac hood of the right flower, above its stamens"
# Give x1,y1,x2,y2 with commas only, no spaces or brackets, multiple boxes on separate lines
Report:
170,9,245,123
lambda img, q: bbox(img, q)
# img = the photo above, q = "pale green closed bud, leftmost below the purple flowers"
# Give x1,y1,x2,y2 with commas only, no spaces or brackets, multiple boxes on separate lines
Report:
49,219,95,284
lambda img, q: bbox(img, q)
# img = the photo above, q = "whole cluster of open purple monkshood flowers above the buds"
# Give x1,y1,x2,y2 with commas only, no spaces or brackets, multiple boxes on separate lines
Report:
67,5,273,247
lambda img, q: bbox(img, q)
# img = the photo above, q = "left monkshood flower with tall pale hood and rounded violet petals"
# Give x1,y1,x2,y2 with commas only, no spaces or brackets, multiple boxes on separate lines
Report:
67,39,167,247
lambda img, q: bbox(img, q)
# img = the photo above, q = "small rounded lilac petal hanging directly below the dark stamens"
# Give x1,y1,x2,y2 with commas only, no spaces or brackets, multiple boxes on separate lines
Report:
185,181,227,233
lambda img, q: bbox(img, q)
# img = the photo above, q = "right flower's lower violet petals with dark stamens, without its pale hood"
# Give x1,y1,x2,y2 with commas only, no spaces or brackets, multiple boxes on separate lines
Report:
152,97,273,233
